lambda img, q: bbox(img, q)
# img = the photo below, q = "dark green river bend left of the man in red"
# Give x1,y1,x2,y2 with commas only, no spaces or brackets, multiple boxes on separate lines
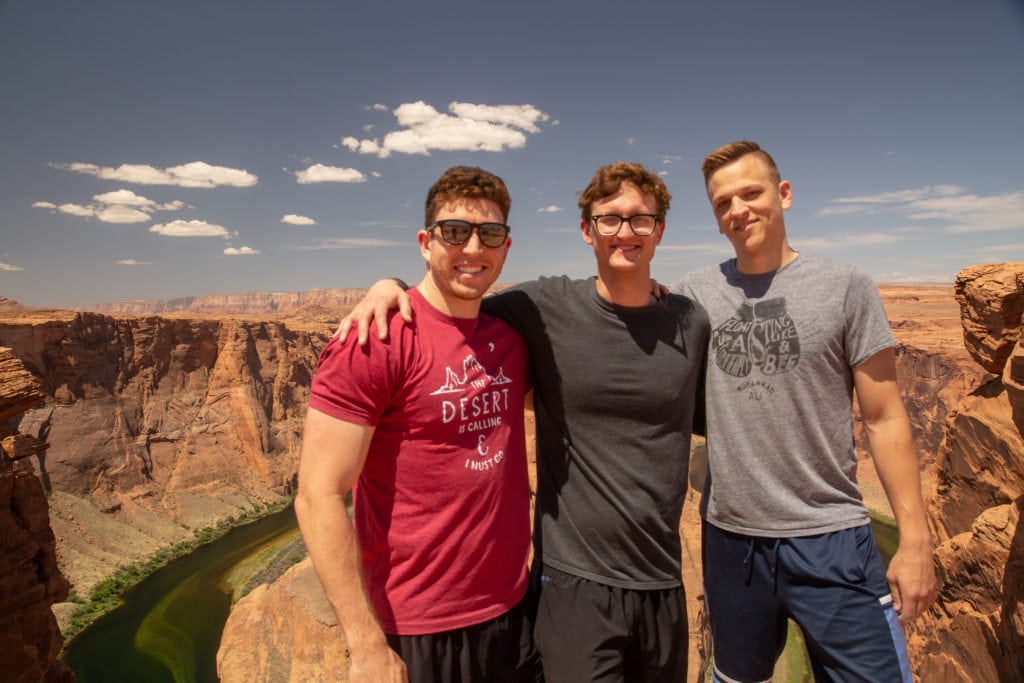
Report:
62,507,296,683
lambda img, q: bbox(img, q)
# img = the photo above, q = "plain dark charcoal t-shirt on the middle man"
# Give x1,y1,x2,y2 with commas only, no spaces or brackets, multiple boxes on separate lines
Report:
483,278,710,590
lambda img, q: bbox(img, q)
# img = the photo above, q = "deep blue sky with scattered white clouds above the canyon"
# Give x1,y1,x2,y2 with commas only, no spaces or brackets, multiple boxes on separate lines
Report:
0,0,1024,306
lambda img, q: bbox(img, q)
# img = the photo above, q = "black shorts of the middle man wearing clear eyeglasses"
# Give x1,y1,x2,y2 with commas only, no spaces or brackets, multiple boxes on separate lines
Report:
534,566,689,683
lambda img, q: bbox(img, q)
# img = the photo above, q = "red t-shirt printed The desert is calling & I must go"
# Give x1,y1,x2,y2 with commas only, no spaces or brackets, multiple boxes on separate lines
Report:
309,289,529,635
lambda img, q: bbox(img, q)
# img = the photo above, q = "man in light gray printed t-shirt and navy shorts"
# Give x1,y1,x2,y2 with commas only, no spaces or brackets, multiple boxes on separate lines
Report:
673,141,935,681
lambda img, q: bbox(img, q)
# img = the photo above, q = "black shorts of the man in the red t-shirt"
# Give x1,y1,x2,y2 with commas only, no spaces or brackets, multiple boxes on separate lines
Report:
387,594,544,683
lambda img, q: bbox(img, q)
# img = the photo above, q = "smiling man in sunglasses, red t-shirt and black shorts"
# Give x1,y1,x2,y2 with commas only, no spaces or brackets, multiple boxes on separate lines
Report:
295,167,540,682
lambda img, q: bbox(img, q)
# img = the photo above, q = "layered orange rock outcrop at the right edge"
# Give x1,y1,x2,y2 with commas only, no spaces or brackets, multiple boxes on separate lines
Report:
910,263,1024,683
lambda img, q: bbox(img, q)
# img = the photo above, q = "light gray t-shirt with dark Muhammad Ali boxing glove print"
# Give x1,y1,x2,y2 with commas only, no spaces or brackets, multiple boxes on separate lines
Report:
672,255,896,537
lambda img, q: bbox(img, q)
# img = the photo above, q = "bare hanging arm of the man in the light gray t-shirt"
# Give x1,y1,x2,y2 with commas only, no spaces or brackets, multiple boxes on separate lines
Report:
853,348,936,622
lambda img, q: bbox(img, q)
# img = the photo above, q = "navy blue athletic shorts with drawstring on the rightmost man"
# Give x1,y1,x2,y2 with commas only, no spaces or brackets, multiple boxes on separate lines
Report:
703,522,912,683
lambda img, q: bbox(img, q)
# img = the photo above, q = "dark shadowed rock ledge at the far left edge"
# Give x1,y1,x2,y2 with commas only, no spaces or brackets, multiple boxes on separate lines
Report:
0,348,74,683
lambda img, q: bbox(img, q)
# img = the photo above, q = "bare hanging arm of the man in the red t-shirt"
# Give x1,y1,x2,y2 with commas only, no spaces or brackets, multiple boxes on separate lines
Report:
295,408,408,683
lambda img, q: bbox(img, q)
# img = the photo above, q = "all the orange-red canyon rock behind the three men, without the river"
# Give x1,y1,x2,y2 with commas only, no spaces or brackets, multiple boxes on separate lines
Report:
0,270,1024,682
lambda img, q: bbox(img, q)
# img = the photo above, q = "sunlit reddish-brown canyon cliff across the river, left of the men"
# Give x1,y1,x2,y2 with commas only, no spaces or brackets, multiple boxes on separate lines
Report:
0,313,327,595
